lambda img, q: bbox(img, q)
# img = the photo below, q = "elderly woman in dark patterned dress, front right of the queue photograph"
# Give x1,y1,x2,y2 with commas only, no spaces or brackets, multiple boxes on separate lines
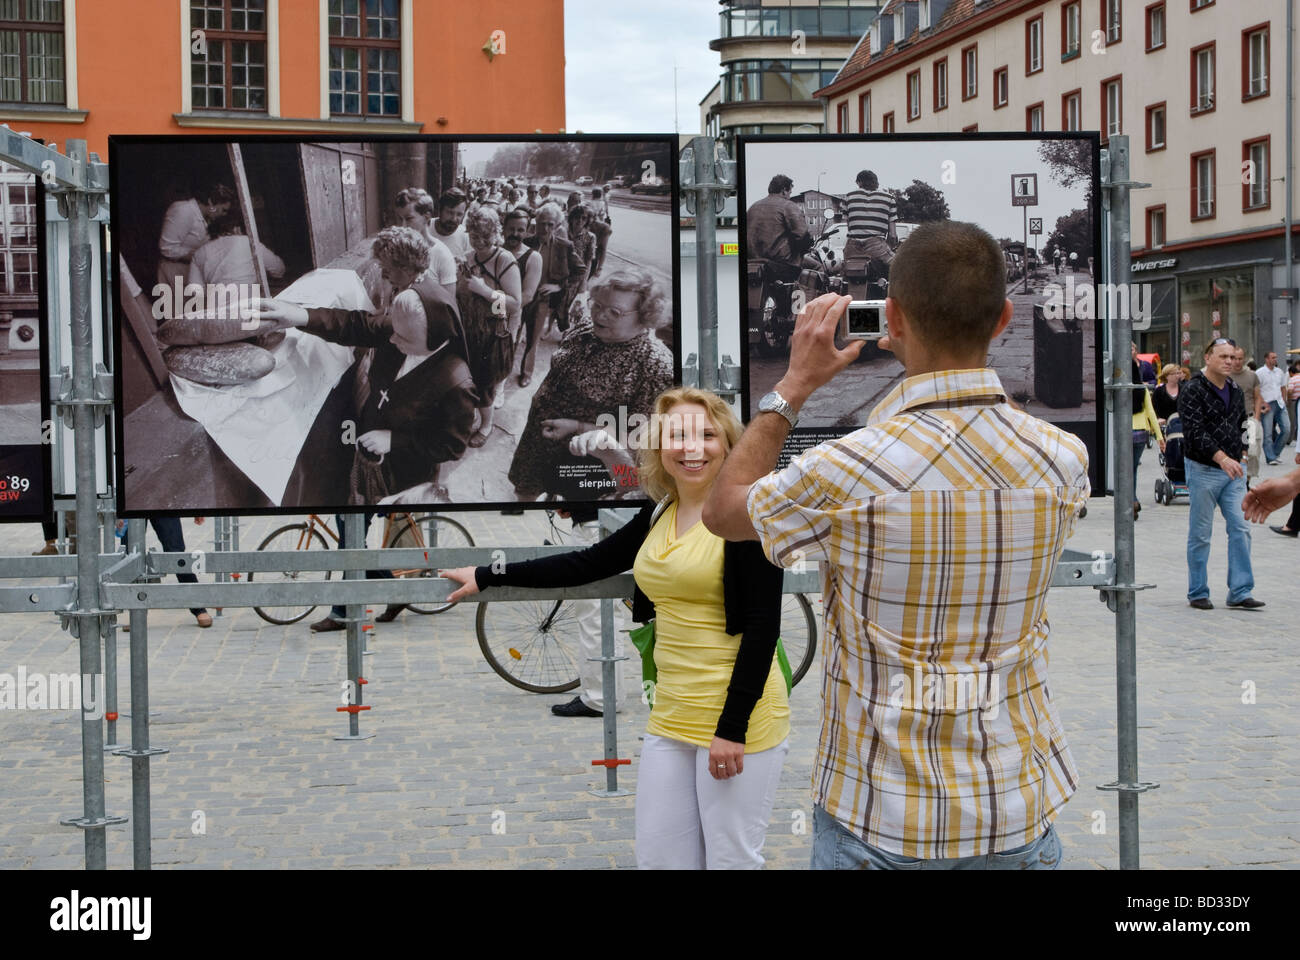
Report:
510,267,672,501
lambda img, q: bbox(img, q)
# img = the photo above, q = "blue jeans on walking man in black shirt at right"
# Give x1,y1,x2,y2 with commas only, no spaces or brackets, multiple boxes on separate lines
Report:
1186,460,1255,604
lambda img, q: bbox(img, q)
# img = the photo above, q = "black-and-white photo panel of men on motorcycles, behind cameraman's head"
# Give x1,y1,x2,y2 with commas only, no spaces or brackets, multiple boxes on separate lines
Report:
738,134,1105,489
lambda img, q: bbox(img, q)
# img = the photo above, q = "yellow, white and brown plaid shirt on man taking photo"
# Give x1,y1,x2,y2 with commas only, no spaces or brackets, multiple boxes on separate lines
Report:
748,369,1088,859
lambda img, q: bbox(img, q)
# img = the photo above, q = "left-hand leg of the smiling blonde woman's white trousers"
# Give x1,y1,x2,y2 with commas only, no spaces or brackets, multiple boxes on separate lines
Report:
636,734,705,870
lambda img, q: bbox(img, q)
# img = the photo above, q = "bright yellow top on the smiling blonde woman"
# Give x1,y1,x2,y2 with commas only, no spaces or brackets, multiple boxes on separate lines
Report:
632,503,790,753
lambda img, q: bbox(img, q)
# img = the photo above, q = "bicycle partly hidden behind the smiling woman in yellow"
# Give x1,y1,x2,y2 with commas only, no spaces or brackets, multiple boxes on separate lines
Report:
475,510,818,693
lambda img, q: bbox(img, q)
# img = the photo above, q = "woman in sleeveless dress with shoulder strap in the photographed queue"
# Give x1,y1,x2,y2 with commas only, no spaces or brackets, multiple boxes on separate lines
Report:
456,207,523,446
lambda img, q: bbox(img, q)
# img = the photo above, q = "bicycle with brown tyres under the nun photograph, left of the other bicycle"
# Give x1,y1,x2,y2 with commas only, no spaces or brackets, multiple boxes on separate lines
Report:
248,513,475,626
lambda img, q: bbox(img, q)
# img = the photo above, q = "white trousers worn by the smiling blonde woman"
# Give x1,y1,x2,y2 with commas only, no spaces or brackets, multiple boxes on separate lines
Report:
637,734,790,870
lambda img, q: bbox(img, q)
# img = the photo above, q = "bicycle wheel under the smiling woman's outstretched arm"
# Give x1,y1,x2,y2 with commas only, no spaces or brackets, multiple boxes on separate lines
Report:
475,600,580,693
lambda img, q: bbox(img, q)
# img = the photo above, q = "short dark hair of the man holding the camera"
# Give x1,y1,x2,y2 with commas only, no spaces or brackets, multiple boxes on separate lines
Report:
889,220,1006,354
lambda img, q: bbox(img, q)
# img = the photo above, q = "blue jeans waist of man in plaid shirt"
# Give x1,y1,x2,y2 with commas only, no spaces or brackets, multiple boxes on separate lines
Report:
813,807,1061,870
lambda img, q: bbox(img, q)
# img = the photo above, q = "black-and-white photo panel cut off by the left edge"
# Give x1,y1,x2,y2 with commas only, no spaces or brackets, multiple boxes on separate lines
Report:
0,163,49,523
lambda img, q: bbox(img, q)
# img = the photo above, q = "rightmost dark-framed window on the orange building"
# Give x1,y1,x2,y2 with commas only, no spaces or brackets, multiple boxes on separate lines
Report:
329,0,402,117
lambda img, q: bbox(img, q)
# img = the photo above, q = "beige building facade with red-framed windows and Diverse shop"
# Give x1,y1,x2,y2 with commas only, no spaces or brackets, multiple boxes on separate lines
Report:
818,0,1300,366
